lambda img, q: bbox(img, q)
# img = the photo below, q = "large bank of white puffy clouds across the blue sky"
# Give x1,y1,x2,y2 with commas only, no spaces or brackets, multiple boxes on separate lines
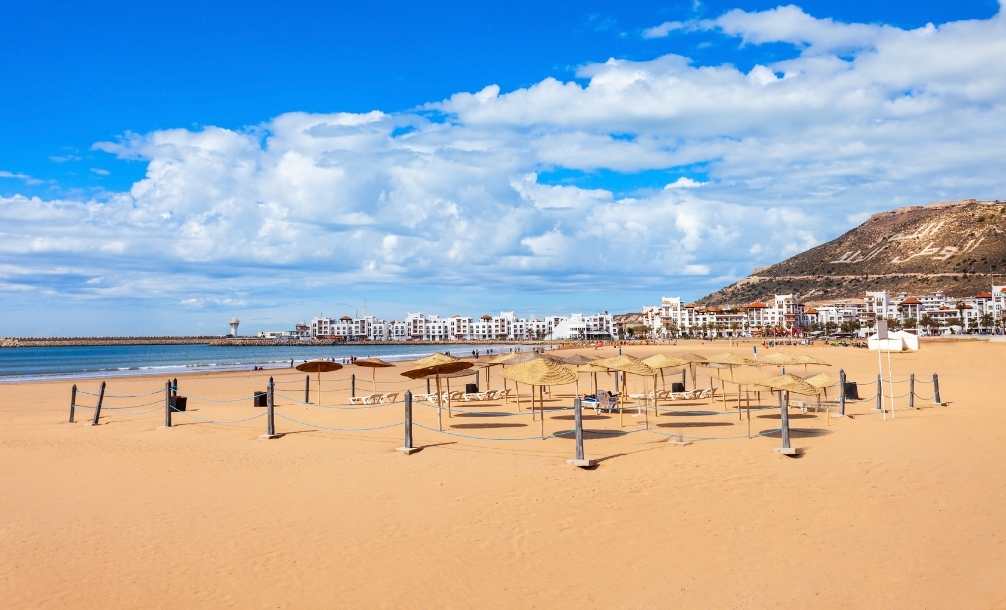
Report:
0,1,1006,316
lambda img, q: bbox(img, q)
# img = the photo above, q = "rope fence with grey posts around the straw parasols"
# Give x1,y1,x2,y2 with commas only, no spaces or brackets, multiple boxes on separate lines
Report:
67,370,950,467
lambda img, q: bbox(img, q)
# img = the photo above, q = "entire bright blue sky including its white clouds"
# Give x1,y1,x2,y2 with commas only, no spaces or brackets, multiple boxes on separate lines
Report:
0,0,1006,335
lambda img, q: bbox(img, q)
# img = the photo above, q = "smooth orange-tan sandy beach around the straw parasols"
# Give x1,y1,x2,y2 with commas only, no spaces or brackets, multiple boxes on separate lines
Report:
0,341,1006,608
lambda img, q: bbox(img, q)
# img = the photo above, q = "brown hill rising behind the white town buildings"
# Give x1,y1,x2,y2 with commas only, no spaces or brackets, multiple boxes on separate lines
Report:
699,199,1006,304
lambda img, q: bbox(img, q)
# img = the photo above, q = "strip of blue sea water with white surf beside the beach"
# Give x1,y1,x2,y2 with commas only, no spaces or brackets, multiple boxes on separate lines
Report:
0,344,526,383
